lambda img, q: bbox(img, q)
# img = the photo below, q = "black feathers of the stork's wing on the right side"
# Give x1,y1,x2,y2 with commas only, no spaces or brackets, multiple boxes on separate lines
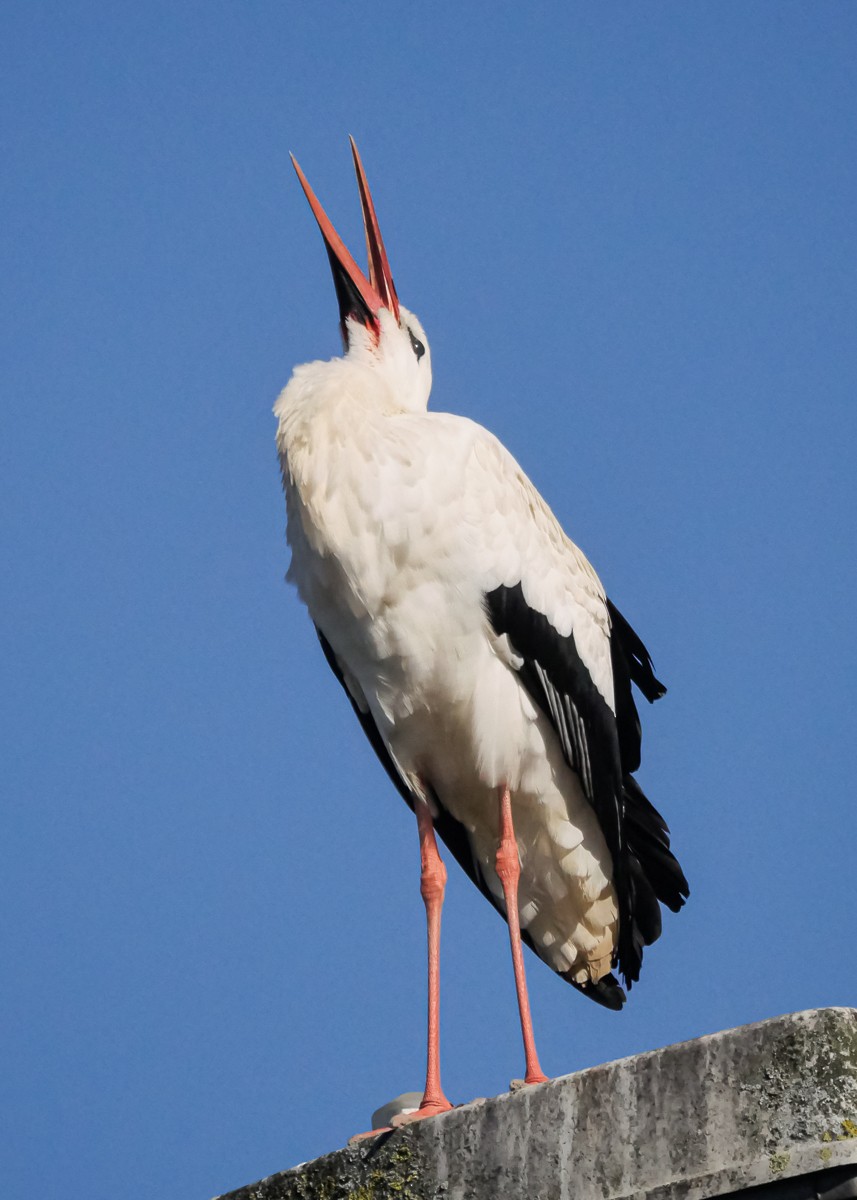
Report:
485,583,688,988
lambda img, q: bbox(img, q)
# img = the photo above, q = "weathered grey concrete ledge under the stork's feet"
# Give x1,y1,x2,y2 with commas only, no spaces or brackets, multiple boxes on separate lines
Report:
221,1008,857,1200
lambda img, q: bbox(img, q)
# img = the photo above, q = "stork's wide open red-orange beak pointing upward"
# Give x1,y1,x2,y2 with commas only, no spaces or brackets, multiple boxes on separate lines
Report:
292,138,398,346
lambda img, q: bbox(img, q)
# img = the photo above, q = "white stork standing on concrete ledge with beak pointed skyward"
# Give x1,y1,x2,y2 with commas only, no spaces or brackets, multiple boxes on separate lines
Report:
275,140,688,1116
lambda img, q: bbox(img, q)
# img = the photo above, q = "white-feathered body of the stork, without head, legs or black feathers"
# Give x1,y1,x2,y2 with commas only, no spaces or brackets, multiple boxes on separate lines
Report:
277,364,617,983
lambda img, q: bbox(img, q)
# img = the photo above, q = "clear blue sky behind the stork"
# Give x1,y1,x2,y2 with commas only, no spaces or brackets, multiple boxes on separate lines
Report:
0,7,857,1200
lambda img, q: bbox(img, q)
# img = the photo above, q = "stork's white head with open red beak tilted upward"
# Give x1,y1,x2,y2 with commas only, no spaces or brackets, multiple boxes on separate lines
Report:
292,138,431,410
